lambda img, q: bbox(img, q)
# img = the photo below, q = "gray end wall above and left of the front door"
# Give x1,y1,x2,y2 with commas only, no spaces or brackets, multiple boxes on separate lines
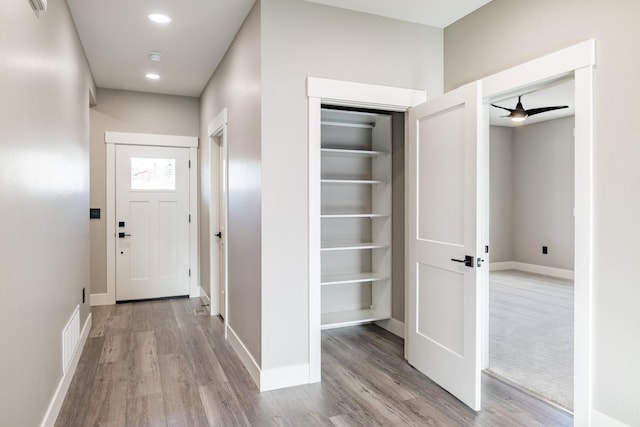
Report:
90,88,200,294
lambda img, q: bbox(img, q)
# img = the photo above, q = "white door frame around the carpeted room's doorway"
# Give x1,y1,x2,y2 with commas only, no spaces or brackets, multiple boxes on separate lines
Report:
482,40,596,426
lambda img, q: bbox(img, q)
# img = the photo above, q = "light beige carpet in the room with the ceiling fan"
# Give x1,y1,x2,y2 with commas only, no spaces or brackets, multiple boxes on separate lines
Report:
489,270,573,410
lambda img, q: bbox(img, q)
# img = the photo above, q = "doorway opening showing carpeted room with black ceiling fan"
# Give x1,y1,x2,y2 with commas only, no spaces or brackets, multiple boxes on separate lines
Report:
484,78,575,412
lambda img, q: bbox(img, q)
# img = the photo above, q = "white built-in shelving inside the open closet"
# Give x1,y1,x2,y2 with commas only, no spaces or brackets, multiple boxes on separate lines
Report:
320,108,392,328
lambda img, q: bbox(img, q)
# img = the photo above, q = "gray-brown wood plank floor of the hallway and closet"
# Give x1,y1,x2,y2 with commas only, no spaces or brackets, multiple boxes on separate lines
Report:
56,299,573,427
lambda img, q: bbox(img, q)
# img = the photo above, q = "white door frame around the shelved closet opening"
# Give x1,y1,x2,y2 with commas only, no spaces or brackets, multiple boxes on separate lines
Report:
307,77,427,383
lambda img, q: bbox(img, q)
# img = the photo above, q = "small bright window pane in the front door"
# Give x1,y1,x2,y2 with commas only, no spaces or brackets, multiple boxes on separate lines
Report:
131,157,176,190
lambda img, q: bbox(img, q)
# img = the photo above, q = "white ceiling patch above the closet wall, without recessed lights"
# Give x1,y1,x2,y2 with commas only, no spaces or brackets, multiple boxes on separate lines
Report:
307,0,491,28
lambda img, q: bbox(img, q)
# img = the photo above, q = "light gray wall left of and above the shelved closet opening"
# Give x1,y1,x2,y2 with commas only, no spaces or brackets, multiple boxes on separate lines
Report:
262,0,442,369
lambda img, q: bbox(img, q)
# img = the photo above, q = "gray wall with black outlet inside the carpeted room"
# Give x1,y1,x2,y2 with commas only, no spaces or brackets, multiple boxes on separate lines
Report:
511,116,575,271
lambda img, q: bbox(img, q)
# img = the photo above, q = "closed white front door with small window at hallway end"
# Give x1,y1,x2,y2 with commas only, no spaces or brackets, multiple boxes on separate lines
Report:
115,145,190,301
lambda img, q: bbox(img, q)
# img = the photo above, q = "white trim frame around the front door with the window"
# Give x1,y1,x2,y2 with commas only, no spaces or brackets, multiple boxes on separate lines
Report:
102,132,200,305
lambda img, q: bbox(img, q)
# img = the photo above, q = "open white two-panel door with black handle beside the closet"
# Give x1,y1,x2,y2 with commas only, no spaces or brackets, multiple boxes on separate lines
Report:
407,82,484,410
